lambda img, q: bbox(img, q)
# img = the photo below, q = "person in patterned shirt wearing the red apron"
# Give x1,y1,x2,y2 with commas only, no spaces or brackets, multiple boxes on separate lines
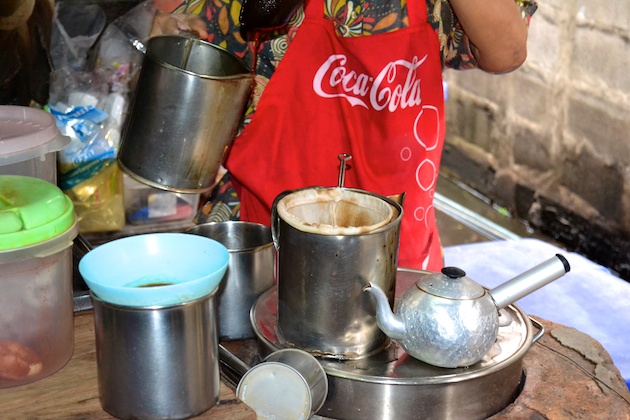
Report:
151,0,537,270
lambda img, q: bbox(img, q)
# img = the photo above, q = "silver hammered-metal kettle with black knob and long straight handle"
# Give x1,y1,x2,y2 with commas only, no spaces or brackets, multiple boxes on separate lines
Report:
363,254,570,368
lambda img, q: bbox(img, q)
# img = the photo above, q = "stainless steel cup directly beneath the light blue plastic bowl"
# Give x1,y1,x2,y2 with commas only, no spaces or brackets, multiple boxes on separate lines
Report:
92,294,220,419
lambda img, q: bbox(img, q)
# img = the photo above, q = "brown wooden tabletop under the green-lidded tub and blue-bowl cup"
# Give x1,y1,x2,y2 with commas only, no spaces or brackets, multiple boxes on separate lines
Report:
0,311,256,420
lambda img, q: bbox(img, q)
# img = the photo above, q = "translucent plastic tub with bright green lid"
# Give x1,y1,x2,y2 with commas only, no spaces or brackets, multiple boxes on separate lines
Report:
0,175,78,388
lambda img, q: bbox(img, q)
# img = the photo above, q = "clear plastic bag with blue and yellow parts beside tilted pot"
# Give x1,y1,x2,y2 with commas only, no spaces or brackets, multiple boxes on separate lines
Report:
48,2,158,233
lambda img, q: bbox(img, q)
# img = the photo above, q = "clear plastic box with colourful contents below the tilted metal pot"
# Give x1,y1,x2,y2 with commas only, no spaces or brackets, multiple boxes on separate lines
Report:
123,174,199,225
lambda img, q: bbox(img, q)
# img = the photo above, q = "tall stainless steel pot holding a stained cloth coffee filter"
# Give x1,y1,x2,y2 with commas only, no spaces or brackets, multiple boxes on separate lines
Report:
272,188,402,360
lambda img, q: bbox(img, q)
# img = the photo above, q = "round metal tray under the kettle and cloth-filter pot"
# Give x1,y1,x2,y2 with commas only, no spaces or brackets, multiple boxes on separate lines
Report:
250,269,544,419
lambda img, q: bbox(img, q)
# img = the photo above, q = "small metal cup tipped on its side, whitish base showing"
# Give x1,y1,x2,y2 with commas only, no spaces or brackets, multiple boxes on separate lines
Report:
236,349,328,419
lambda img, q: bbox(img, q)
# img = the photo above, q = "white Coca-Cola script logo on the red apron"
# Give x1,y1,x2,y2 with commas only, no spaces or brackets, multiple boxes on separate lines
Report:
313,54,427,112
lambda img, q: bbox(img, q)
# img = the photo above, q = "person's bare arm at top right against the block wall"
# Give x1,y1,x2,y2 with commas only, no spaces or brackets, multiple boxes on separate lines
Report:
449,0,527,73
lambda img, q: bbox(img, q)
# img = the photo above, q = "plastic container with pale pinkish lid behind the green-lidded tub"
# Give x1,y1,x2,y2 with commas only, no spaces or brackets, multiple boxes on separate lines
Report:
0,105,70,185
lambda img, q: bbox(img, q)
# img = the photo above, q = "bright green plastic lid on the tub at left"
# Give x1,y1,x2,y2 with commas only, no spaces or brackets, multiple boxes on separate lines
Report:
0,175,75,251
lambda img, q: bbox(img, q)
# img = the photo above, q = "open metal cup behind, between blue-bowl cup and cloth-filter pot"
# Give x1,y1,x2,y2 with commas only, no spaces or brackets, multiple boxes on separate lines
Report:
186,222,275,340
